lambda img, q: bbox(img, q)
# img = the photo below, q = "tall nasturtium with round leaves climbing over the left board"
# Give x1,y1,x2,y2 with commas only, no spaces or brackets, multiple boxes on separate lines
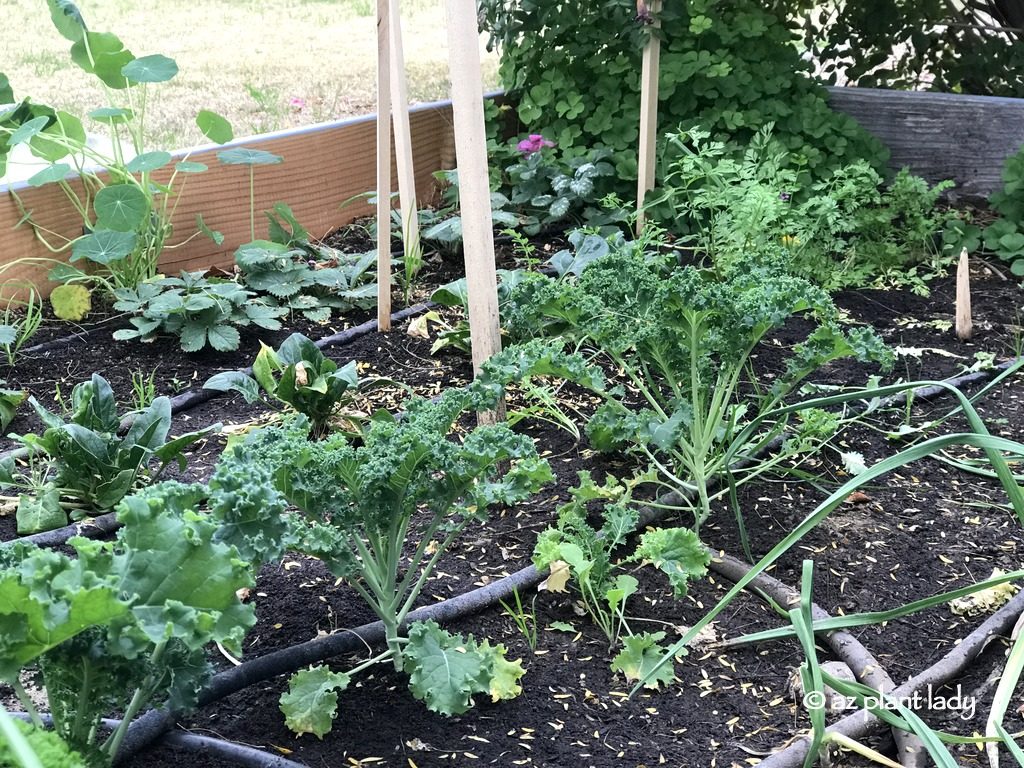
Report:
0,0,231,292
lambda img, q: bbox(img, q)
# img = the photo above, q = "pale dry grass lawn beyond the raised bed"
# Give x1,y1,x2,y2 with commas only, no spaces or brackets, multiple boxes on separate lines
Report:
0,0,497,150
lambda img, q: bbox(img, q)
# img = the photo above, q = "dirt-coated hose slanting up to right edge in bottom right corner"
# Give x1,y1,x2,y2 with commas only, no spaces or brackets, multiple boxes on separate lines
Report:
758,592,1024,768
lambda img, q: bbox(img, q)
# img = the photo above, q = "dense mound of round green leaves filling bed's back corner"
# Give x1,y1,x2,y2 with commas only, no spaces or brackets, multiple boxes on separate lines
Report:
480,0,886,186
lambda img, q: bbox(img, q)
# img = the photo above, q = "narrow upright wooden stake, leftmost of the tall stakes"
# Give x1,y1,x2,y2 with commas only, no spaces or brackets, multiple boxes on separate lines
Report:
377,0,391,331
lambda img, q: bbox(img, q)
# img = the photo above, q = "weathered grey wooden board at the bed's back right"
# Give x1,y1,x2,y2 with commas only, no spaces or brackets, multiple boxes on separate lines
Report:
828,88,1024,200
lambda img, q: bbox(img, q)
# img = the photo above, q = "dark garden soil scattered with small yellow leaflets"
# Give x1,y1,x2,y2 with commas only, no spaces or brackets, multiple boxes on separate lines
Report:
0,253,1024,768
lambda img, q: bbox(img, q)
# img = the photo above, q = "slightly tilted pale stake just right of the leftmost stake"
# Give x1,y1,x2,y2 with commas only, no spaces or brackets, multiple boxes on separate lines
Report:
388,0,420,280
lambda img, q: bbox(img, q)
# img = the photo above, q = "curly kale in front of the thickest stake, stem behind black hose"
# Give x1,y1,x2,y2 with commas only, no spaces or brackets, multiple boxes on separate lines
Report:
240,390,552,670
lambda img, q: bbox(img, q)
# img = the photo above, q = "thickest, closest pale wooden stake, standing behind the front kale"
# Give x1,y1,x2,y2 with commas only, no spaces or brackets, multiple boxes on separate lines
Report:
447,0,504,423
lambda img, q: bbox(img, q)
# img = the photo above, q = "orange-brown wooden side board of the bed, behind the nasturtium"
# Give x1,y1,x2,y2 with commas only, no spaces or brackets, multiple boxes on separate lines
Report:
0,102,452,291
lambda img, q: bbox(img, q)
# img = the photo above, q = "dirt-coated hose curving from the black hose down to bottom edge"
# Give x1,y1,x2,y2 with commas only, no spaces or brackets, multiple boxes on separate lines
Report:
710,553,928,768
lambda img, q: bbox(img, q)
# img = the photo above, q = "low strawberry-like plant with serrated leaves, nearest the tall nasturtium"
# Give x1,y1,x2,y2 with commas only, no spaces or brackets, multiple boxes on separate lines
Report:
114,271,288,352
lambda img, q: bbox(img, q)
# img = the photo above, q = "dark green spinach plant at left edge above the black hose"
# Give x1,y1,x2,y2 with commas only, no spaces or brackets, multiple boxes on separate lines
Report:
0,374,219,534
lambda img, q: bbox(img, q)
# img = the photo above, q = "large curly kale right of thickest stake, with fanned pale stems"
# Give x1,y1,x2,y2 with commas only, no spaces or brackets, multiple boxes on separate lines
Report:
509,250,889,525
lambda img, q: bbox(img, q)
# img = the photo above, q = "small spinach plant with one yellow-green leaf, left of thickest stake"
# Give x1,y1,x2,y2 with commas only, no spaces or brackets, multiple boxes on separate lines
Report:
203,333,366,437
